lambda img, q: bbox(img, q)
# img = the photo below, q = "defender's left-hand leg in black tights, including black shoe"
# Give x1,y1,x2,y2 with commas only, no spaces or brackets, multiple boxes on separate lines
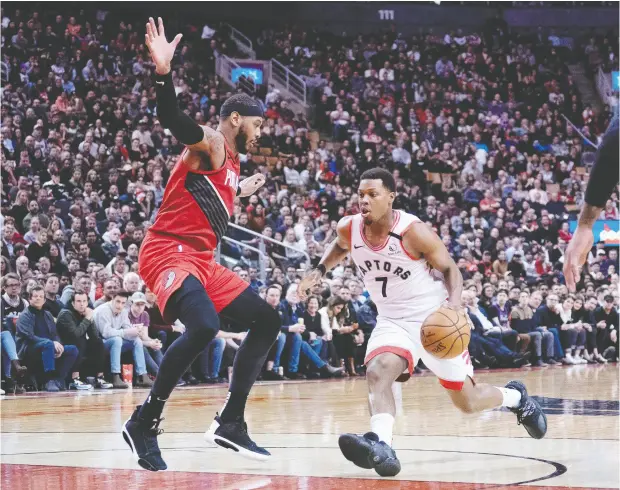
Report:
123,275,220,471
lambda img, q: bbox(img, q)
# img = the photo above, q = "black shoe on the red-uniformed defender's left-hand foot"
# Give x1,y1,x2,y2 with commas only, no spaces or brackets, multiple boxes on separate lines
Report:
123,405,168,471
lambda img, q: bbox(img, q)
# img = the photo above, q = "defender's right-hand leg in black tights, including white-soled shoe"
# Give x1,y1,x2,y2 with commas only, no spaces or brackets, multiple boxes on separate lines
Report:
205,286,280,460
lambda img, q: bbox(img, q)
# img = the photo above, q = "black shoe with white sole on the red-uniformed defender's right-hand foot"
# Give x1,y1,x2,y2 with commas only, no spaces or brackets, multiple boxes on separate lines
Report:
205,414,271,461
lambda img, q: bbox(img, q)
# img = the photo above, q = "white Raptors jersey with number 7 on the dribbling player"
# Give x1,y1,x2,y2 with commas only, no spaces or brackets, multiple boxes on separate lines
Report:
351,210,448,322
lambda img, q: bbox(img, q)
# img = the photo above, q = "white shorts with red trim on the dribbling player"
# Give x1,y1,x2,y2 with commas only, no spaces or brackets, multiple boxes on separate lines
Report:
364,317,474,391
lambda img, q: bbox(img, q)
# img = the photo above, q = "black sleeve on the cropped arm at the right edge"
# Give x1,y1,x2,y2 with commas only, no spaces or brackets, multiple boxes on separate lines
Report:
586,117,619,208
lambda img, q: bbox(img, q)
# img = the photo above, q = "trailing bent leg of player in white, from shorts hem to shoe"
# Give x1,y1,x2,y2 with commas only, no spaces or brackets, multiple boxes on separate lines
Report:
422,351,547,439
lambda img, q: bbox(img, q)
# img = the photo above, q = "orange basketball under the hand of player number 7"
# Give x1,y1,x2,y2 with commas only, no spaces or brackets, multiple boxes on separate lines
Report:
420,308,471,359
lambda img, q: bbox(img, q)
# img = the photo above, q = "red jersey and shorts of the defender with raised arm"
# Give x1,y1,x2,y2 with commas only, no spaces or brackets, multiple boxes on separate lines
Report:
138,140,248,321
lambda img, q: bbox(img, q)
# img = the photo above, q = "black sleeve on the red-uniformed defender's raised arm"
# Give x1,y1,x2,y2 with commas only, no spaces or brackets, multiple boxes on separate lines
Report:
155,73,204,145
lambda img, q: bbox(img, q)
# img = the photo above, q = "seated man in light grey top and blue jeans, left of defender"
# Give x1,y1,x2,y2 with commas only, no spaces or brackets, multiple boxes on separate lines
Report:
94,291,153,388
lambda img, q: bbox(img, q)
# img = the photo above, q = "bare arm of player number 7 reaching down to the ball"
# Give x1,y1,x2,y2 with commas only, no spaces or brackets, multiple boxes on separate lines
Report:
403,223,463,309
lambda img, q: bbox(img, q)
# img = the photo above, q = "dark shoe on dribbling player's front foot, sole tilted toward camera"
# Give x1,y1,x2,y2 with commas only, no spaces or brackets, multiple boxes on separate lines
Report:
338,432,400,476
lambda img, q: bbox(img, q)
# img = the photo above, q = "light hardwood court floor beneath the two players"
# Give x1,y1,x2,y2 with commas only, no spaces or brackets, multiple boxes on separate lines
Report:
0,364,620,490
